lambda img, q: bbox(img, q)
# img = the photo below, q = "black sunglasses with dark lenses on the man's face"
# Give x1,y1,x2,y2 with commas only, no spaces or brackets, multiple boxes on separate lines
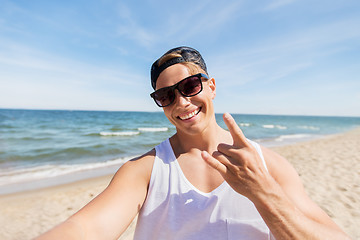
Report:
150,73,209,107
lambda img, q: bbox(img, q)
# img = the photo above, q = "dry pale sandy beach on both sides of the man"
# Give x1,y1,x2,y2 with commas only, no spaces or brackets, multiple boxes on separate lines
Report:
0,128,360,240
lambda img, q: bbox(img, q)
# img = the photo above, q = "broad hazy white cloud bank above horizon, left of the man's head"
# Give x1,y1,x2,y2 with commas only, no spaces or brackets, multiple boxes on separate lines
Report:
0,38,148,110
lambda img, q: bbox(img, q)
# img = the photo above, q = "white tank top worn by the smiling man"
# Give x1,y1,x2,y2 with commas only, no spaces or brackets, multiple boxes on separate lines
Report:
134,139,271,240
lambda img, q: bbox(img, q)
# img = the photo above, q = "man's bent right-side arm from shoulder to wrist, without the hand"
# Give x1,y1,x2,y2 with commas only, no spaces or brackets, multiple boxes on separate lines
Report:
257,148,349,239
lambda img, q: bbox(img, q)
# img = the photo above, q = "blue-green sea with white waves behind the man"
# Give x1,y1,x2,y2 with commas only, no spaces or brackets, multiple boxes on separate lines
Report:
0,109,360,194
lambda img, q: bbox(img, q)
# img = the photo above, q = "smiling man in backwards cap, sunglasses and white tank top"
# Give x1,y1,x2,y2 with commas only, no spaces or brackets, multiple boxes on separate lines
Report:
39,47,348,239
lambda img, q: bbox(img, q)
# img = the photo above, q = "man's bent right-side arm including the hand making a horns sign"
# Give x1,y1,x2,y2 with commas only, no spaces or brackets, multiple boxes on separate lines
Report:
203,114,349,239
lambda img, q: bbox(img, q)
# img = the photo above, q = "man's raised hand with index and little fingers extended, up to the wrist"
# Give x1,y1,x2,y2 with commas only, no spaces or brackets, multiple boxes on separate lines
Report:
202,113,275,202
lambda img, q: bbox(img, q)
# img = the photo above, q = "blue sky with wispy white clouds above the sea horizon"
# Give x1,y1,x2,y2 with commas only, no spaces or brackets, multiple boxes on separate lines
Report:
0,0,360,116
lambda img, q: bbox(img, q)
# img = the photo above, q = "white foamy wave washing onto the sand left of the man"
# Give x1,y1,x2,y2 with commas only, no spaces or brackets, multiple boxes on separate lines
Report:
0,156,136,186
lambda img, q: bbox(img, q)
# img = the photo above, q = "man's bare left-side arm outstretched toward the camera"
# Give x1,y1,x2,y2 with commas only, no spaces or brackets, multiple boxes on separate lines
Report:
37,150,155,240
